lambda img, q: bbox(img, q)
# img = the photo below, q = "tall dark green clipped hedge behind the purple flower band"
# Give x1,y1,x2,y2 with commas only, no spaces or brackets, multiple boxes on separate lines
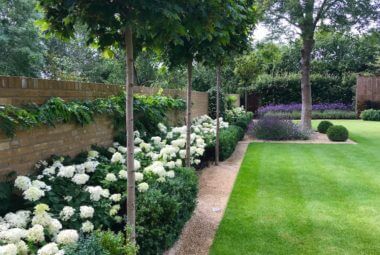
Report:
251,73,356,105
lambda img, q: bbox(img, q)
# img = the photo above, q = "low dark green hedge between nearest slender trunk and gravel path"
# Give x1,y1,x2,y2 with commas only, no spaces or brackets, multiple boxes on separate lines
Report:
136,168,198,254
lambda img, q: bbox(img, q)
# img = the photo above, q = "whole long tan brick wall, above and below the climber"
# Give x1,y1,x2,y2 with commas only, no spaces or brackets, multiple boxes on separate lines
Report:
0,76,208,178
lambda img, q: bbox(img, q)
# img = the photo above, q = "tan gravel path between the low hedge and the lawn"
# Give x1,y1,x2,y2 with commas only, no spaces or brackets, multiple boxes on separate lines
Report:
165,138,251,255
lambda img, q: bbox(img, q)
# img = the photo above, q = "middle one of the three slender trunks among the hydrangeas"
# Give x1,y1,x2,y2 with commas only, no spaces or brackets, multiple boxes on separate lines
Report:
186,59,193,167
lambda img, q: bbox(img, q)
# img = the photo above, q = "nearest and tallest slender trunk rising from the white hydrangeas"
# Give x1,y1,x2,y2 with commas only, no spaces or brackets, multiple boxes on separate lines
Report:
125,27,136,241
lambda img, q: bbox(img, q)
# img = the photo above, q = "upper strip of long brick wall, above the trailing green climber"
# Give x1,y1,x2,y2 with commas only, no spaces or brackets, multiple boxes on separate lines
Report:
0,76,208,117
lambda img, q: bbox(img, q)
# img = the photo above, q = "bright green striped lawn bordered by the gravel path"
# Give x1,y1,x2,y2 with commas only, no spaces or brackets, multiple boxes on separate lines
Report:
210,120,380,255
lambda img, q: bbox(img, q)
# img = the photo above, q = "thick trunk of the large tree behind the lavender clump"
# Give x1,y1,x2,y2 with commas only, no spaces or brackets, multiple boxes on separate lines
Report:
301,38,314,130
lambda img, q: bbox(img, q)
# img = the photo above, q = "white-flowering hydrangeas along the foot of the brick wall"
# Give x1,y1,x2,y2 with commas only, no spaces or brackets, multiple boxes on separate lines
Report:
0,116,232,255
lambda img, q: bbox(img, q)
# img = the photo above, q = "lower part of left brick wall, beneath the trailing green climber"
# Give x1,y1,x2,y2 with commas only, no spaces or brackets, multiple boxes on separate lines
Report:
0,117,114,176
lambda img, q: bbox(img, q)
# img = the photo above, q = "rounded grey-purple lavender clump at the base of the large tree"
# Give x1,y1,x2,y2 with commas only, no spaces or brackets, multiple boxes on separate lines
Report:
252,117,310,140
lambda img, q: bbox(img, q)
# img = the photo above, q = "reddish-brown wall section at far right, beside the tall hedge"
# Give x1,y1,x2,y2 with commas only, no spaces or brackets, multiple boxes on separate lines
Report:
356,76,380,114
